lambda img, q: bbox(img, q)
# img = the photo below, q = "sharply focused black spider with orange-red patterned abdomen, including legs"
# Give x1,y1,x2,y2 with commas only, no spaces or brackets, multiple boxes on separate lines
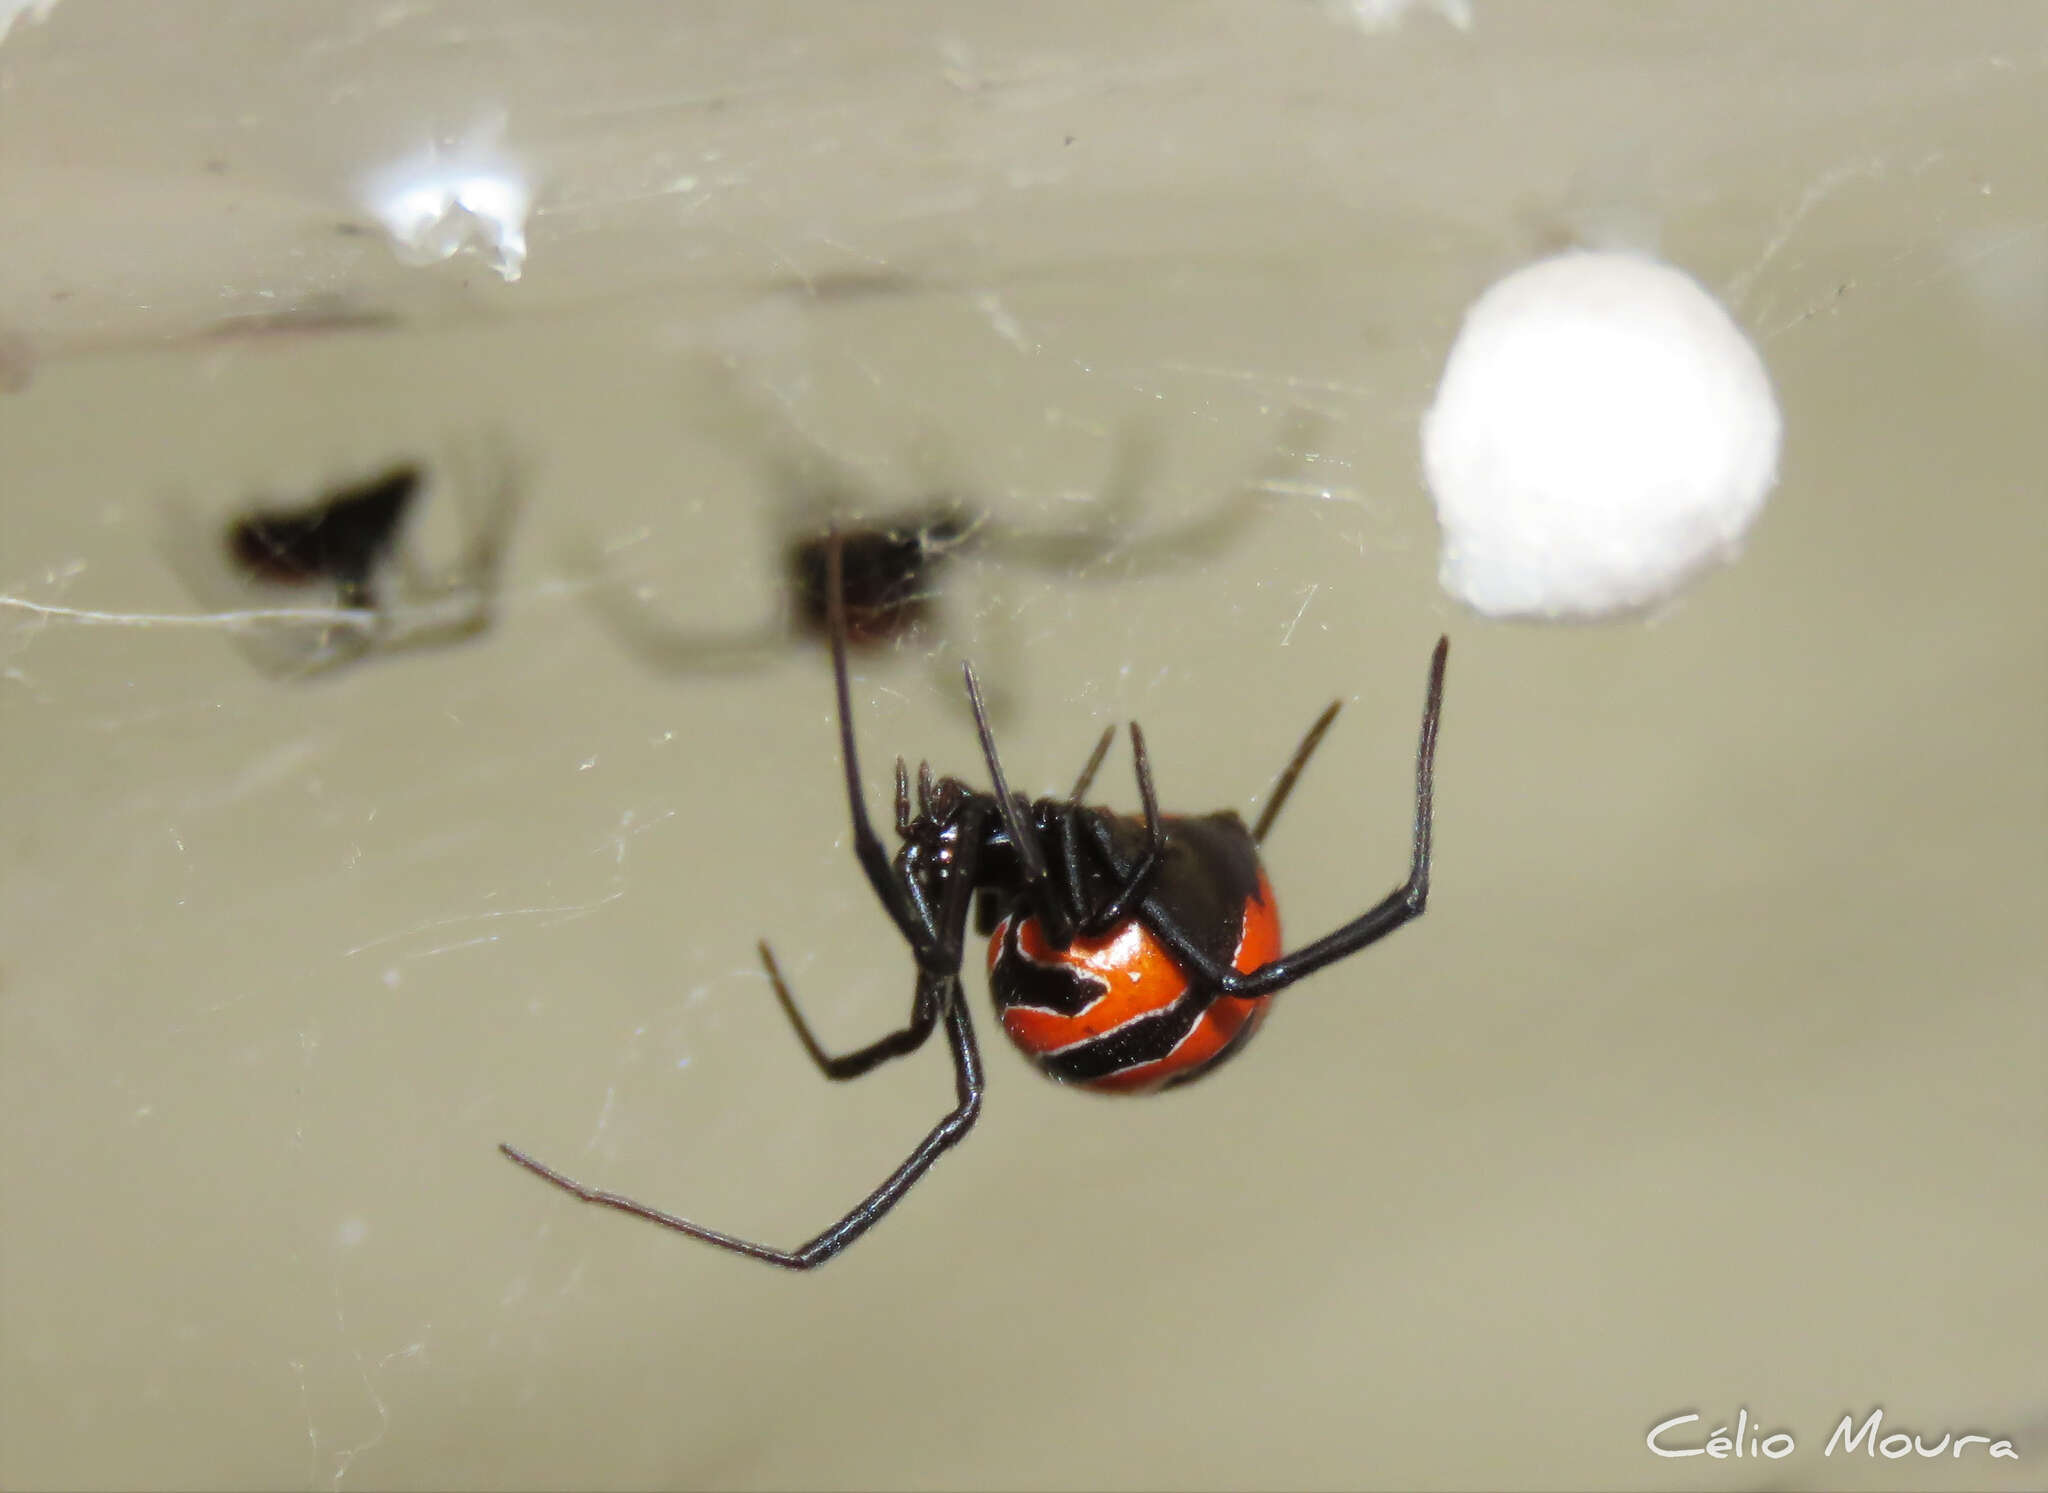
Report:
500,535,1450,1270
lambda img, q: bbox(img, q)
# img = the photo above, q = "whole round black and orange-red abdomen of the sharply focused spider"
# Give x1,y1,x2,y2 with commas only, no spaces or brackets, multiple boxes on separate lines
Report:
989,815,1280,1094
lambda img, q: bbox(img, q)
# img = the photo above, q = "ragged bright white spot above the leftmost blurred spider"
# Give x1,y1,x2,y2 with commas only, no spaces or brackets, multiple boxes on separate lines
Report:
362,119,532,281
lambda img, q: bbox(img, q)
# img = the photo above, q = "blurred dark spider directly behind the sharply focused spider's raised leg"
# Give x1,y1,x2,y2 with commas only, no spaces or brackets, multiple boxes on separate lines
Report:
586,391,1319,715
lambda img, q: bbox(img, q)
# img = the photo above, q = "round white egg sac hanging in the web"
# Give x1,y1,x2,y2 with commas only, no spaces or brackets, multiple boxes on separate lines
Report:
1421,252,1780,621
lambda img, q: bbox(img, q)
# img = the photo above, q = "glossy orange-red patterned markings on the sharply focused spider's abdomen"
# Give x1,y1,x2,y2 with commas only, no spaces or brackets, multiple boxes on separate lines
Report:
989,875,1280,1094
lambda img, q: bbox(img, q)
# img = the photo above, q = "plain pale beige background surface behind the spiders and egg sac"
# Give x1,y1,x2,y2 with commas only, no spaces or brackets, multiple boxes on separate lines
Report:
0,0,2048,1489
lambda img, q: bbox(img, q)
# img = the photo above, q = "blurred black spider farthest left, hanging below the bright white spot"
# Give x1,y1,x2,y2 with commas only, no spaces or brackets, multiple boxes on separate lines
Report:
172,440,518,678
